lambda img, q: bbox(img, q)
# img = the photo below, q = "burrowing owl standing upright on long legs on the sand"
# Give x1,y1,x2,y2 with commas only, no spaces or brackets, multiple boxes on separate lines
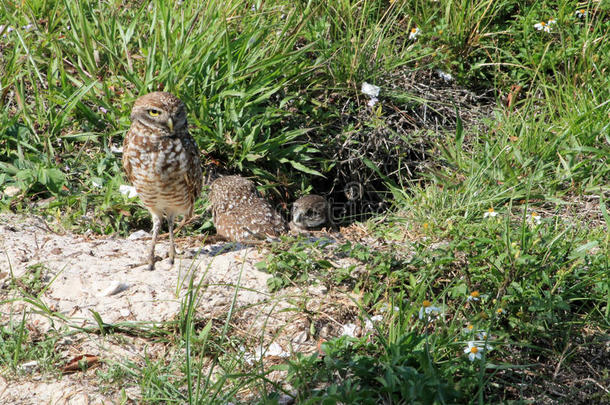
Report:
123,92,202,270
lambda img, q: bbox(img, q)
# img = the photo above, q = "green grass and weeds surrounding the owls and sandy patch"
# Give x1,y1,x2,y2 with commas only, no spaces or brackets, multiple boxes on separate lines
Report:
0,0,610,404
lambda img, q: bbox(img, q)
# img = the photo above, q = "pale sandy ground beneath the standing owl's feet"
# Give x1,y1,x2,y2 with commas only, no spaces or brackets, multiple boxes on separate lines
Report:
0,214,366,404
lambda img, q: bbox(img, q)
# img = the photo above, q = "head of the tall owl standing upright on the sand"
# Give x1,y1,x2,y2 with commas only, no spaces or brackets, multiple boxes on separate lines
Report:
130,91,187,135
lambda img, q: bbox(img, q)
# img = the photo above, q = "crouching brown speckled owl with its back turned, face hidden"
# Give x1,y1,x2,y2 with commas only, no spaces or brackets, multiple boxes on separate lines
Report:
208,176,286,242
